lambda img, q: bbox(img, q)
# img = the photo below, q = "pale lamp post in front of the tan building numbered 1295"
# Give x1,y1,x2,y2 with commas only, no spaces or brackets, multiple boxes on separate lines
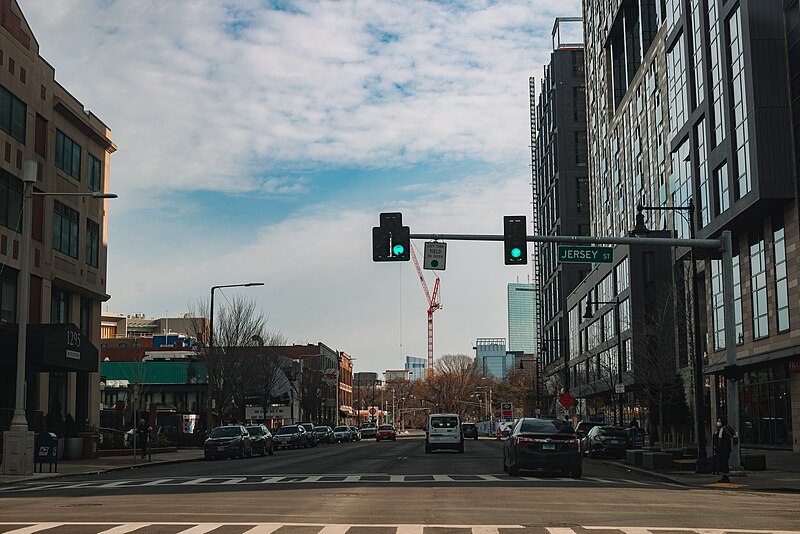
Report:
3,160,117,475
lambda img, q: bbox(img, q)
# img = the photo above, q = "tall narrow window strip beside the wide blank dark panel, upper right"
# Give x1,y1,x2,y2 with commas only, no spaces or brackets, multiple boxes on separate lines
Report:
728,7,751,200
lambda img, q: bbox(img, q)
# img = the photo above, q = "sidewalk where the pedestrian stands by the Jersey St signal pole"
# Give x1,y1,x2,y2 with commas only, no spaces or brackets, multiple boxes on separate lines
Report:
604,449,800,493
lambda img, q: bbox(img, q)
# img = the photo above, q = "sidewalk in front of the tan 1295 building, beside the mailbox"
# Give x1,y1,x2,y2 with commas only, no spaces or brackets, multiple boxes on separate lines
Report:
0,448,203,486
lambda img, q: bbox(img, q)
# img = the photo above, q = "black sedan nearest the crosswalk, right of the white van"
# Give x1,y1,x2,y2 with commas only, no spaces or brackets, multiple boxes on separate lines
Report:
503,417,583,478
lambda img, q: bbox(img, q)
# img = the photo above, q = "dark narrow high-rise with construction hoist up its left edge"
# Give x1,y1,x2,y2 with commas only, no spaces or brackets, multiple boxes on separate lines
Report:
536,18,591,376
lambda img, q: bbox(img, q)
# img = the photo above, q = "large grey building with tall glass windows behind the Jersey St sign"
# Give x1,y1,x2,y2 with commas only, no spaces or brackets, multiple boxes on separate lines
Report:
583,0,800,452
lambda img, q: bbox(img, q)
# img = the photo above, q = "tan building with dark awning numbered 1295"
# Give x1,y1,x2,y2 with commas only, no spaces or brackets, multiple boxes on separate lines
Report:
0,0,117,442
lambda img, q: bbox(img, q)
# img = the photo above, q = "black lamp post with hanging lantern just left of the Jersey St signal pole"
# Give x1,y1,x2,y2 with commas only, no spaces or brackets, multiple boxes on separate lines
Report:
631,203,711,473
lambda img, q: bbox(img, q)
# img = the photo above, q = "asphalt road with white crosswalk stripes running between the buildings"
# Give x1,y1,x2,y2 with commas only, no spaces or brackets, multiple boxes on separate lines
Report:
0,438,800,534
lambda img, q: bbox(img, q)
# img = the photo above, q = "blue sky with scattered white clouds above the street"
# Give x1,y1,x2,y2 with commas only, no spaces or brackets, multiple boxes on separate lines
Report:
18,0,581,372
